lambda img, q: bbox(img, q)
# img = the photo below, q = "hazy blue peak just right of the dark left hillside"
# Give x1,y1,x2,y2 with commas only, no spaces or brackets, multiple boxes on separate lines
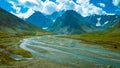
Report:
26,11,52,29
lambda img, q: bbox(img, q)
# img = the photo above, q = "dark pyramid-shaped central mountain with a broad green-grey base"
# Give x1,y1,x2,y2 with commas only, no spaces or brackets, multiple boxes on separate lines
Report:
51,10,96,34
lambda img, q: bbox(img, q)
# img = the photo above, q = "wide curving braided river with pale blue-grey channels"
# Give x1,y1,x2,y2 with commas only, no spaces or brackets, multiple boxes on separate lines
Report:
20,36,120,68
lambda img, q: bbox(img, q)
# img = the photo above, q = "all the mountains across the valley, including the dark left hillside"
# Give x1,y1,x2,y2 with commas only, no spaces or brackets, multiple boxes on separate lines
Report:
0,5,120,34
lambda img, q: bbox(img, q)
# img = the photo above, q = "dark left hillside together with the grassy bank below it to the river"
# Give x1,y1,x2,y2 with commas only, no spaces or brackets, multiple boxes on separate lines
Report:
0,8,49,68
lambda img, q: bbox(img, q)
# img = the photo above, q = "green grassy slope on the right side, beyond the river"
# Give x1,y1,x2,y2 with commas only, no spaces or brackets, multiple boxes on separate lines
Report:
62,21,120,51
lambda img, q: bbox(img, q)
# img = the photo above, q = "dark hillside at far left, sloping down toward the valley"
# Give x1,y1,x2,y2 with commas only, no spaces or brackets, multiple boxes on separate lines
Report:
0,8,41,33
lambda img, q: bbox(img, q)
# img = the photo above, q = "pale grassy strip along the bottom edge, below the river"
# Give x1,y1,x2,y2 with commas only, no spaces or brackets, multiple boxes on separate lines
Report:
10,60,74,68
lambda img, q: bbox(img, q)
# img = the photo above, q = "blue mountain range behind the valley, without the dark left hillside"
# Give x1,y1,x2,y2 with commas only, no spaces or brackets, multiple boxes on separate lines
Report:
21,10,120,34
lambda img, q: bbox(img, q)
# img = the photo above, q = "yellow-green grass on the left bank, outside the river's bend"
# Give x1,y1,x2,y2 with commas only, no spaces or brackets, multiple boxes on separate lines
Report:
0,32,52,65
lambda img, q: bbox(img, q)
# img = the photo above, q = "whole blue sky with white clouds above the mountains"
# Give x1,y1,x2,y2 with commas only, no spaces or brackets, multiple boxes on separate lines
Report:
0,0,120,19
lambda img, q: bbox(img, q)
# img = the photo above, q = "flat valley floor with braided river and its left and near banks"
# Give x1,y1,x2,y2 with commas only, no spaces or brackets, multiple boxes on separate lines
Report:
0,35,120,68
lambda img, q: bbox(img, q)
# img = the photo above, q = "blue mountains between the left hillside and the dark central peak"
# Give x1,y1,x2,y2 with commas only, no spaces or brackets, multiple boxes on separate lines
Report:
26,11,64,30
